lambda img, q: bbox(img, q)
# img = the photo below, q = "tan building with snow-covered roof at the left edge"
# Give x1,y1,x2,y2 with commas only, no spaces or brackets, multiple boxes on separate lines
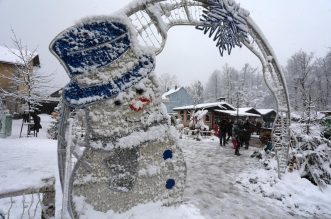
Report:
0,46,40,113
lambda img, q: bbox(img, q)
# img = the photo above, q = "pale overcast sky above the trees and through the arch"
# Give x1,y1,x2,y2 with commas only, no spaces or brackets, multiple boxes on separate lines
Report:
0,0,331,92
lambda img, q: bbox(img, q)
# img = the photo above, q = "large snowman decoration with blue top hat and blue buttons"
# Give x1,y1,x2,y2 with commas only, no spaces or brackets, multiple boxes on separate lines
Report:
50,17,186,218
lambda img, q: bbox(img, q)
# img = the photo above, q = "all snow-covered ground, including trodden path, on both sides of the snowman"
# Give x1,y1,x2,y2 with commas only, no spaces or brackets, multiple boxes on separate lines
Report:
0,115,331,219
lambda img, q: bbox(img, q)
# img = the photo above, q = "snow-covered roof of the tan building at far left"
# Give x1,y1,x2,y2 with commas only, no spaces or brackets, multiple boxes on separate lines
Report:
0,46,39,65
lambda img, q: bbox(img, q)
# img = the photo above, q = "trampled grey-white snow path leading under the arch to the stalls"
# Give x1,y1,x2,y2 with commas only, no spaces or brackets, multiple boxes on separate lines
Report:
180,138,303,219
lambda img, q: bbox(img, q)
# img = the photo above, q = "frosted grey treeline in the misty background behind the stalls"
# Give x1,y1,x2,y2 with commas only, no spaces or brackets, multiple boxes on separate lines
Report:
160,49,331,111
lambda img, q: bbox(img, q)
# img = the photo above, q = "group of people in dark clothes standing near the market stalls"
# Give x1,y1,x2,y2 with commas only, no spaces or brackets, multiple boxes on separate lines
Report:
218,119,253,156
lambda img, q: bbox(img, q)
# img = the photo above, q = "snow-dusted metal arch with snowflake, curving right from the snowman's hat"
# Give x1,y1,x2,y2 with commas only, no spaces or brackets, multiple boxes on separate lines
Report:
121,0,291,178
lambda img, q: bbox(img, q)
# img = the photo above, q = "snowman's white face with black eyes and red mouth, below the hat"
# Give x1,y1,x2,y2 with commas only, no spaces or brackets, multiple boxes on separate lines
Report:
87,74,167,142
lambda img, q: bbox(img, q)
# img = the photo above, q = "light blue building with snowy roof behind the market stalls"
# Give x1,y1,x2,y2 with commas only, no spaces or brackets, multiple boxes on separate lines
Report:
162,87,193,114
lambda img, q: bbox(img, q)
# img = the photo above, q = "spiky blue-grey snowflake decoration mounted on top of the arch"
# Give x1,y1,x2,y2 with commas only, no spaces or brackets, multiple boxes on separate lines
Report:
196,0,249,56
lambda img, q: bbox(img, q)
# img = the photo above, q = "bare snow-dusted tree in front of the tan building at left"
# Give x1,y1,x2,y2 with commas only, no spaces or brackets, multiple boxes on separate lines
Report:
0,30,52,111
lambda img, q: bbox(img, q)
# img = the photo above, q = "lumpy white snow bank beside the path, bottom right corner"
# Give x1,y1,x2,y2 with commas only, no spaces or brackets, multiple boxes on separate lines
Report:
237,162,331,218
